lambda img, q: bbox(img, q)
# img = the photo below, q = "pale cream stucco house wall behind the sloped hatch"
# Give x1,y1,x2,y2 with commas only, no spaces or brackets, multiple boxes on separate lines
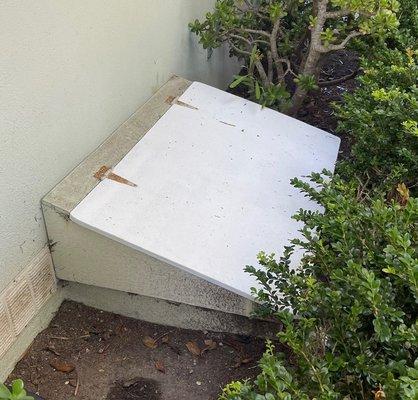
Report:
0,0,236,291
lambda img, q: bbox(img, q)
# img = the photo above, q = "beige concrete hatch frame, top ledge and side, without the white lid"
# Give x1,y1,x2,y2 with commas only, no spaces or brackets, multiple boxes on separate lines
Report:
42,76,254,323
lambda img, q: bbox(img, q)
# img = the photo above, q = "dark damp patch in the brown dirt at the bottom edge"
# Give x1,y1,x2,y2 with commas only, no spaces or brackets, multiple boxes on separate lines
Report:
106,378,160,400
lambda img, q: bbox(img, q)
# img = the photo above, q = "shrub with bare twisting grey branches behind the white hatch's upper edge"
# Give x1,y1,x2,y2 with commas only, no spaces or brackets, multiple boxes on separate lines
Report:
190,0,398,113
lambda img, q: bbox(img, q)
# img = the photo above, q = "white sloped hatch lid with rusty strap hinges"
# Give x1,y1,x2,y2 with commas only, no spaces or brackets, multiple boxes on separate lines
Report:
70,82,340,297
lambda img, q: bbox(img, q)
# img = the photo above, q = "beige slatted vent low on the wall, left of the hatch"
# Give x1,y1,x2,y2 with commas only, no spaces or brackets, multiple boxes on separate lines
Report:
0,247,56,357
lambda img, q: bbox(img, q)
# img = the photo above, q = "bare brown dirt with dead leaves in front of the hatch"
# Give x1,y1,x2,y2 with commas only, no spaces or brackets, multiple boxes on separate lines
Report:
9,302,264,400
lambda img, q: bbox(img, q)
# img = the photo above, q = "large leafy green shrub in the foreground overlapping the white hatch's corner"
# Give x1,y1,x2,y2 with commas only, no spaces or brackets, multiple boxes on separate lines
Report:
221,174,418,400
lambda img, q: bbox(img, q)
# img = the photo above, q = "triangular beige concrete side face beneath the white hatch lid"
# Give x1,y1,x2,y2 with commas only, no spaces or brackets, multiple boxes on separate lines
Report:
44,205,253,323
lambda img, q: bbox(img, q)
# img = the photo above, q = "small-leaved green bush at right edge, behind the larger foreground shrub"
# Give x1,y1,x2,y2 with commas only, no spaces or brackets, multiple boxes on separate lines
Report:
337,47,418,193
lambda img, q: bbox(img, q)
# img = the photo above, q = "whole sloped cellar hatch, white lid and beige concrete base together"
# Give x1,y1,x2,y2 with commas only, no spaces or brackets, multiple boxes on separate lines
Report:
42,77,339,323
